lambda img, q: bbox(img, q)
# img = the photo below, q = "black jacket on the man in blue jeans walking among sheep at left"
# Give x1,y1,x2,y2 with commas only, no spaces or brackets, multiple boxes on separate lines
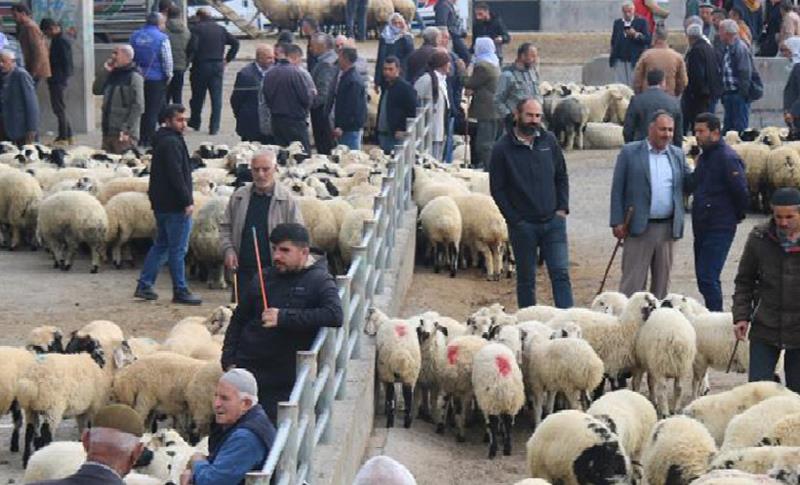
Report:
147,127,194,213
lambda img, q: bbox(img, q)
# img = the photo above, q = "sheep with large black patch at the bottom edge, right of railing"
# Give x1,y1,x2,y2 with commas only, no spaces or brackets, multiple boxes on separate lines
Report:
527,410,631,485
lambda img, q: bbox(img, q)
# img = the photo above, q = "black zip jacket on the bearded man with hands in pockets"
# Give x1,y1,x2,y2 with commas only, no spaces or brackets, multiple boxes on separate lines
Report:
489,131,569,227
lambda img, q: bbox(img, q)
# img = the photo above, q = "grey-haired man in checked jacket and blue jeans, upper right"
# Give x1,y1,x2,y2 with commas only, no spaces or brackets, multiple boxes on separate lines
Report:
719,19,755,133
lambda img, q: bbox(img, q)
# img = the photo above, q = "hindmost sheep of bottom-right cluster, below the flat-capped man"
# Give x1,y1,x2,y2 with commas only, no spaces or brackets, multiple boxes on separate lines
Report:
683,381,793,445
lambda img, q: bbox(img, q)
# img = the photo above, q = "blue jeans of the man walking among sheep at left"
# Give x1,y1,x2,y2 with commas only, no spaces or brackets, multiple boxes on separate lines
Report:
139,212,192,293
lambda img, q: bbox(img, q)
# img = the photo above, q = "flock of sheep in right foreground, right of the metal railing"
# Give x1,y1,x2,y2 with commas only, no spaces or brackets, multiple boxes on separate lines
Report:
365,292,800,485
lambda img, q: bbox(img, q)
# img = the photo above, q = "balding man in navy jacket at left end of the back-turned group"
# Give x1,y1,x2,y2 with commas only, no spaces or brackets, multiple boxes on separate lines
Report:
231,44,275,144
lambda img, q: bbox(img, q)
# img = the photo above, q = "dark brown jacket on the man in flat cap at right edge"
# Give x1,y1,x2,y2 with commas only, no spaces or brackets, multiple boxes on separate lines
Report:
731,221,800,349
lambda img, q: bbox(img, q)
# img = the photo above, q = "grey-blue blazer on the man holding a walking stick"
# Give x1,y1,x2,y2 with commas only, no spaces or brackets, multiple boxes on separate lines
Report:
609,140,692,239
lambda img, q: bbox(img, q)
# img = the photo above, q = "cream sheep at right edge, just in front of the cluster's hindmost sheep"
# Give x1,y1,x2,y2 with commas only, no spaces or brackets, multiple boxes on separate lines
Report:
720,395,800,451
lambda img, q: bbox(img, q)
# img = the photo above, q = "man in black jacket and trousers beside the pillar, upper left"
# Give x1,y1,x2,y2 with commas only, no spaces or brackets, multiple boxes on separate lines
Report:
40,18,73,145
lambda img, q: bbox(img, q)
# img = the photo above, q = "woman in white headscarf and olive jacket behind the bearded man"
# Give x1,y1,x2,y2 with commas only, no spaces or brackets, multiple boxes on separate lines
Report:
464,37,500,171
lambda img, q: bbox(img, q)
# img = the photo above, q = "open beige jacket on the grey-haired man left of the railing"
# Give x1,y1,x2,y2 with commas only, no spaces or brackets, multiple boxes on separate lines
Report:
219,181,303,257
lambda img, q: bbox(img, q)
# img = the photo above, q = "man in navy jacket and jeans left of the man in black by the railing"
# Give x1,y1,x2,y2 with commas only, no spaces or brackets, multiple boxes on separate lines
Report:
333,47,367,150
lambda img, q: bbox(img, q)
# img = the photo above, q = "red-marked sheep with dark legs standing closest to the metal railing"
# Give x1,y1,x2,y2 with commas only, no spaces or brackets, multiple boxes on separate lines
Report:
364,308,422,428
